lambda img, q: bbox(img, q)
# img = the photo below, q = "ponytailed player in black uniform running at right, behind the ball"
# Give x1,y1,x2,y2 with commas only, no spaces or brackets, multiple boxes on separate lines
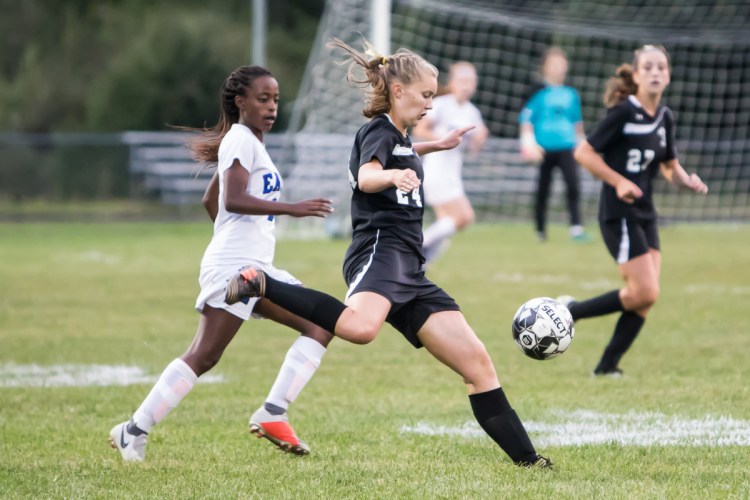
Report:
569,45,708,375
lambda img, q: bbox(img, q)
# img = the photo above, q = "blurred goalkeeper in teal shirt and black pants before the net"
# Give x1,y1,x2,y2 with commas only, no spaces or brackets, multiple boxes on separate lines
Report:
518,47,590,242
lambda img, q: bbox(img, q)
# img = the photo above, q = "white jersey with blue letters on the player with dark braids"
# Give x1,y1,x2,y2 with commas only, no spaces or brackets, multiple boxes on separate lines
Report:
201,123,282,268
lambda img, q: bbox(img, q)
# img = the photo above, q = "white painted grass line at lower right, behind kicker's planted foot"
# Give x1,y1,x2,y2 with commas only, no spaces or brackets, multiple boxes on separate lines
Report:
401,410,750,446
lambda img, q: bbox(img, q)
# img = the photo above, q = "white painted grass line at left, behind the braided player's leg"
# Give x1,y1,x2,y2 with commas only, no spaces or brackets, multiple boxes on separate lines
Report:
0,363,224,387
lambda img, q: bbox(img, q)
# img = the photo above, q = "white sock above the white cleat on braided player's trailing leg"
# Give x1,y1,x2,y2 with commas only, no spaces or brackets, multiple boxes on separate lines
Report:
133,358,198,432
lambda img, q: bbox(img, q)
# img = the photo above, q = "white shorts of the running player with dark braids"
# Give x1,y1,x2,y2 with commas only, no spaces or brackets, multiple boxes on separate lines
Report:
195,262,302,321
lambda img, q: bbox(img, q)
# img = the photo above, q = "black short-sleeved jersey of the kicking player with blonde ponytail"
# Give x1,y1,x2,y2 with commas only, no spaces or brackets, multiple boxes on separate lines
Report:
349,115,424,256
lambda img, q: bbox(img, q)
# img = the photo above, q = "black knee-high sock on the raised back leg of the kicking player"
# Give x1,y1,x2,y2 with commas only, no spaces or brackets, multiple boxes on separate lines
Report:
263,275,346,334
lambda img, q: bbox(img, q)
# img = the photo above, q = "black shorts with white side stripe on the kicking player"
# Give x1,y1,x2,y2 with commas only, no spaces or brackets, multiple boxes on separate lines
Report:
344,230,461,348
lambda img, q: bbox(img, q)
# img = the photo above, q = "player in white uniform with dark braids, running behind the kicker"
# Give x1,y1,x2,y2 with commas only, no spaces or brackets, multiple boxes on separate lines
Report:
110,66,333,461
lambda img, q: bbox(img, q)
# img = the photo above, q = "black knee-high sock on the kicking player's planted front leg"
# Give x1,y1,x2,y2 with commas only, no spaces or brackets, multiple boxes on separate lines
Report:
469,387,538,463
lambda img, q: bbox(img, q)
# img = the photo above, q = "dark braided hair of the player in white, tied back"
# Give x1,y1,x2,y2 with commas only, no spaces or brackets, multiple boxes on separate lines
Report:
188,66,273,164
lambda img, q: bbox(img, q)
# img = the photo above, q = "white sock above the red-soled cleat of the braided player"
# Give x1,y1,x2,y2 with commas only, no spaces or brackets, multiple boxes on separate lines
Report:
266,336,326,410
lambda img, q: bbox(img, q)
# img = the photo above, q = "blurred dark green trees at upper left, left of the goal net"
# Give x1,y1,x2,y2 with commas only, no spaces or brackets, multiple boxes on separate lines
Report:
0,0,325,132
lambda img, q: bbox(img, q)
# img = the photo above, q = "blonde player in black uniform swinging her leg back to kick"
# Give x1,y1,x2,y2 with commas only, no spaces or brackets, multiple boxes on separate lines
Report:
226,40,551,468
